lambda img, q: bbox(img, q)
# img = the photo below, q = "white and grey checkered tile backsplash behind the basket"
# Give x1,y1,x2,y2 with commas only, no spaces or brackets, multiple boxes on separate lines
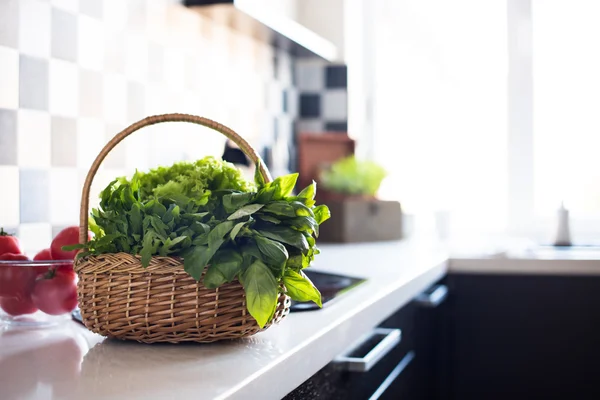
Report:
0,0,302,255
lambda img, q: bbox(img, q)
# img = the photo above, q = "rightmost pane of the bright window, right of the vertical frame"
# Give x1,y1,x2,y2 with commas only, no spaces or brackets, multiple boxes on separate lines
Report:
532,0,600,217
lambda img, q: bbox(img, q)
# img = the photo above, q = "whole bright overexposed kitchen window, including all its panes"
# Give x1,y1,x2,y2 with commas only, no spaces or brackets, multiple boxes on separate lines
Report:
365,0,600,238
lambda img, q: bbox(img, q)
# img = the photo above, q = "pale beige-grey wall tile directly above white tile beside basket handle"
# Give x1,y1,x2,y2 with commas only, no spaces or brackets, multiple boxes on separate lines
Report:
50,117,77,167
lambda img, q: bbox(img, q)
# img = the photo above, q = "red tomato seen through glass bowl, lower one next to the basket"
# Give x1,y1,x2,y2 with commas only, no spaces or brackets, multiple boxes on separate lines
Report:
31,270,77,315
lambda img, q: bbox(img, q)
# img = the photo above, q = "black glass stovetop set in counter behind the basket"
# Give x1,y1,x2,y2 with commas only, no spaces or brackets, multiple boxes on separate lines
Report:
290,270,366,312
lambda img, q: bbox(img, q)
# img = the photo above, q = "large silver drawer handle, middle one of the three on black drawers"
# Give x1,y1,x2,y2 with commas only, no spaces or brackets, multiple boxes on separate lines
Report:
333,328,402,372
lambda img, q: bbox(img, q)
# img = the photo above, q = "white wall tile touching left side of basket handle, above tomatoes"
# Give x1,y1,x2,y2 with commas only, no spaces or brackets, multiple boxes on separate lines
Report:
49,168,81,225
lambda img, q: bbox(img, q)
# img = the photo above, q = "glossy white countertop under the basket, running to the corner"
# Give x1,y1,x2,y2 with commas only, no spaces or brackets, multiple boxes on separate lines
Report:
0,242,447,400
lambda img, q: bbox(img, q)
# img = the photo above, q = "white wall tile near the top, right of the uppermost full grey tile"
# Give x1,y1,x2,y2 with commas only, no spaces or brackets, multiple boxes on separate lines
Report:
77,15,105,71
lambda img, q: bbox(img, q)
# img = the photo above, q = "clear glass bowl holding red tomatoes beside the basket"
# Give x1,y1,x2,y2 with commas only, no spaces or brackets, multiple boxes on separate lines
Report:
0,260,77,327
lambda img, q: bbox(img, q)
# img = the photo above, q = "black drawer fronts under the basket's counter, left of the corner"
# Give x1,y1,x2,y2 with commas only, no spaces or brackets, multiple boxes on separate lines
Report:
285,282,445,400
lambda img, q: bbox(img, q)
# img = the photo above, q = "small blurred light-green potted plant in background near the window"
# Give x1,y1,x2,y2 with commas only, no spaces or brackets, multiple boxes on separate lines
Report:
320,156,386,196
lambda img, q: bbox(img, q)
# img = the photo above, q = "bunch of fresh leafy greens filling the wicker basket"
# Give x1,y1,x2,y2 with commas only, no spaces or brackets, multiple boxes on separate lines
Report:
81,157,329,327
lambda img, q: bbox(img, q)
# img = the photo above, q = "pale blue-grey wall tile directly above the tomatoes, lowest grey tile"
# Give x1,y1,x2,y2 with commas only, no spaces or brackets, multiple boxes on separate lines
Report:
19,169,50,223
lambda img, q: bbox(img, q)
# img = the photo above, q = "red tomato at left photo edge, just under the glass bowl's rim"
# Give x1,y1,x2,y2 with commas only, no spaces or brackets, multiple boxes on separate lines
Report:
0,254,38,298
